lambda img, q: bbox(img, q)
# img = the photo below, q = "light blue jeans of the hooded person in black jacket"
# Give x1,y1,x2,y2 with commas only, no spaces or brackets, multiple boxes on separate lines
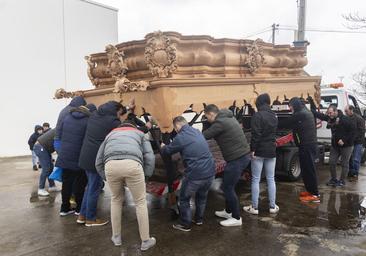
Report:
251,157,276,209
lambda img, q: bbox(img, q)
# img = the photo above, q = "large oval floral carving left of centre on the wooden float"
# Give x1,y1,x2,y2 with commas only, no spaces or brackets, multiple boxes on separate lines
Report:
145,31,178,78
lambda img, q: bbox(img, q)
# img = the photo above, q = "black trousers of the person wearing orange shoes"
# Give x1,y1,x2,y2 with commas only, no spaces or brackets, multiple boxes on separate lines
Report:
299,144,319,195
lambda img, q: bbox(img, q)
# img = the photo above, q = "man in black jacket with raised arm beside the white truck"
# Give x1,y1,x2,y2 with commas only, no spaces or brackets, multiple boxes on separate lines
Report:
309,100,356,187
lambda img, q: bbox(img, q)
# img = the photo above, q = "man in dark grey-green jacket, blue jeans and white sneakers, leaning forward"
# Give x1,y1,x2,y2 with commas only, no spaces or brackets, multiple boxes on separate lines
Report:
203,104,250,226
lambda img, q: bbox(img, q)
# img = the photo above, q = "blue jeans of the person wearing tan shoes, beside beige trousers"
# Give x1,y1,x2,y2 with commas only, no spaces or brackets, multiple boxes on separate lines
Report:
80,171,103,221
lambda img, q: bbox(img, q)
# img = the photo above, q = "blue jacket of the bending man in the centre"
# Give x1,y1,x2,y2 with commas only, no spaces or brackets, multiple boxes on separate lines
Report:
162,124,215,180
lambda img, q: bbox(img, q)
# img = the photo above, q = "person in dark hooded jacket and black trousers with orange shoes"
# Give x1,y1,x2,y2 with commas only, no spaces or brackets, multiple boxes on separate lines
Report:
279,97,320,203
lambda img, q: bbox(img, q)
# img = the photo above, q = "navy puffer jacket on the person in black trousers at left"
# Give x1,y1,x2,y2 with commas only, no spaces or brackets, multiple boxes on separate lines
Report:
56,107,91,170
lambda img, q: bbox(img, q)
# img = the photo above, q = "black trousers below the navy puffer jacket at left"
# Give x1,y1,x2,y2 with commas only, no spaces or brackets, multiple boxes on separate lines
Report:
61,169,88,212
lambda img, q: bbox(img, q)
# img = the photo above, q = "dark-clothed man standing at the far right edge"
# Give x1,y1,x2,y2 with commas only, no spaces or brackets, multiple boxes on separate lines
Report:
344,105,365,181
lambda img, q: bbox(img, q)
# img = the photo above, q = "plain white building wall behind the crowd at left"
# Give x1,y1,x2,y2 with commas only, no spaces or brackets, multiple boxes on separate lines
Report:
0,0,118,157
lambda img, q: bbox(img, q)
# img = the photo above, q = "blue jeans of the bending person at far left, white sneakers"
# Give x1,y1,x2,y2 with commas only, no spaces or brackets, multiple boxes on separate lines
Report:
33,144,55,189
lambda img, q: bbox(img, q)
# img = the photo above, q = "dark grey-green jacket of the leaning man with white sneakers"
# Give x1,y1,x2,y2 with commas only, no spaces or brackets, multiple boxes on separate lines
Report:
203,109,250,162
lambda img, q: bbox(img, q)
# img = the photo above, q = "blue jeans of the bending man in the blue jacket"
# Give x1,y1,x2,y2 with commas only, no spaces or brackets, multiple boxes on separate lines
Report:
179,177,214,227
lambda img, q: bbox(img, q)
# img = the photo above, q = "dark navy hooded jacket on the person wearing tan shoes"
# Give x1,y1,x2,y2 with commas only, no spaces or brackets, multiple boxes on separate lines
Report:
79,101,121,172
